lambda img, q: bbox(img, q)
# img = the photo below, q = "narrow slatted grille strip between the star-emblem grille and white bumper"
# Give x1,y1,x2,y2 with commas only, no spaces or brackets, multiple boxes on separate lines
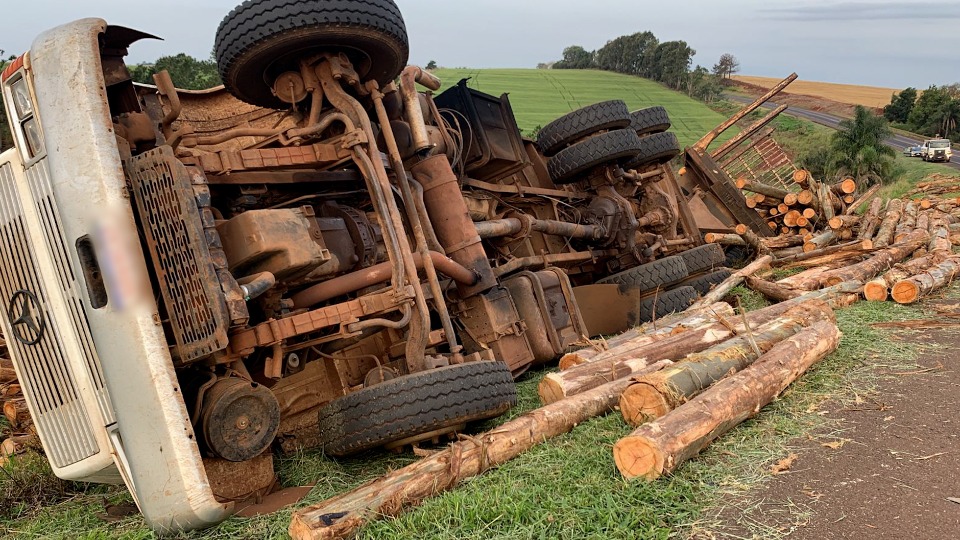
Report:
27,159,115,425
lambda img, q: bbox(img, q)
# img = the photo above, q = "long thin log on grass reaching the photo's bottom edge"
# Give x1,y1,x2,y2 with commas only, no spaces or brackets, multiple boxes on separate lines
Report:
288,379,660,540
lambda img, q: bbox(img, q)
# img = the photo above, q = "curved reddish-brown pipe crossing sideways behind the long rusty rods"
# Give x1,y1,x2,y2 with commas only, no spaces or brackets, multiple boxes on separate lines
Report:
291,251,479,308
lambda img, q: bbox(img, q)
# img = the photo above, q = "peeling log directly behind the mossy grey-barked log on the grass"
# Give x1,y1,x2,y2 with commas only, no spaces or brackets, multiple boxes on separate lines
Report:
537,297,811,404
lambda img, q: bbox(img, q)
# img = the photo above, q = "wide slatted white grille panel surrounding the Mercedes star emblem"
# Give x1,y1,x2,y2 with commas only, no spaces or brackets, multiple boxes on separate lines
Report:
0,164,99,467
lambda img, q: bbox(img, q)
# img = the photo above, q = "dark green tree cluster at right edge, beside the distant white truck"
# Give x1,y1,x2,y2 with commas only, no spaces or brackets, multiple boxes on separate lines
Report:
883,83,960,142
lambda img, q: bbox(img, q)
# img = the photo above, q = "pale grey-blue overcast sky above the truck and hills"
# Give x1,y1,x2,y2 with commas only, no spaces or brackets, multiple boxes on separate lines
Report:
0,0,960,88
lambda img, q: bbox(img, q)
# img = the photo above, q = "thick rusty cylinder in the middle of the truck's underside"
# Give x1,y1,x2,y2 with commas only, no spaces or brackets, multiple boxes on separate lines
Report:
411,155,497,296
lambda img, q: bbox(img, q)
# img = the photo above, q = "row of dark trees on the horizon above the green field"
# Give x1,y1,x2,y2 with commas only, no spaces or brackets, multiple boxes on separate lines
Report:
537,31,740,102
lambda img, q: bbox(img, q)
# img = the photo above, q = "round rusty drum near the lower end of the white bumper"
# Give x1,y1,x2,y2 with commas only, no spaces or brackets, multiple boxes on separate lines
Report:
200,377,280,462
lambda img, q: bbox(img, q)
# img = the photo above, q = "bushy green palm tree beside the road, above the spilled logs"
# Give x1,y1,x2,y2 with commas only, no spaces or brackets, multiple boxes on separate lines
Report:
831,106,897,185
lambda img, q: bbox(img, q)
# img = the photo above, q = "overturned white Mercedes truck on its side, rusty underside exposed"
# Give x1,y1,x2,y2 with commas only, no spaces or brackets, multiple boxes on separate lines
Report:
0,0,725,532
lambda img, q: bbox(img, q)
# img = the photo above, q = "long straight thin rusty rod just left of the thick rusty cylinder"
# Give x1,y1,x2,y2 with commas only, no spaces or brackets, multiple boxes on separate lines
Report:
368,81,462,354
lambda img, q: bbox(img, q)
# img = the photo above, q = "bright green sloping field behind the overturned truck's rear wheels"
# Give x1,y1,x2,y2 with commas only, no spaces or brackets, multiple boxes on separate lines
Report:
434,69,734,146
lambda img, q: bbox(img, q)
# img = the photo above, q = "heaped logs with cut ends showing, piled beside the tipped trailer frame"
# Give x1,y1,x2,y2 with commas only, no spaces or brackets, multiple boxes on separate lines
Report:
736,169,858,236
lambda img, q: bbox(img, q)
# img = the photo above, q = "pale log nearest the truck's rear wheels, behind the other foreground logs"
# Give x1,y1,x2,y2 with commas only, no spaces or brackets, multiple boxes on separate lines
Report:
560,302,734,370
